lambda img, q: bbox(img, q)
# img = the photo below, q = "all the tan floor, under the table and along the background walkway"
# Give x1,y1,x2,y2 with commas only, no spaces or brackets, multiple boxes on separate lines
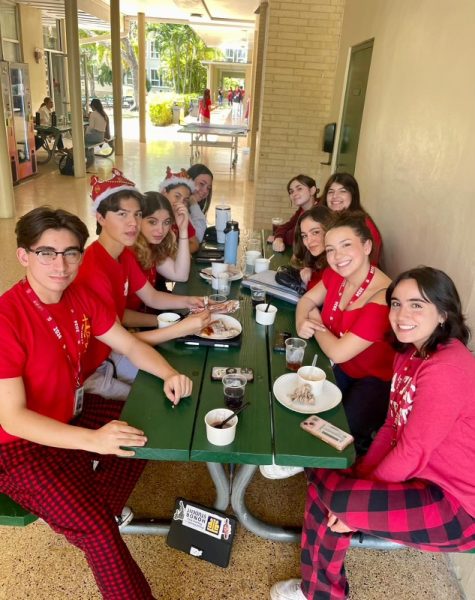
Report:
0,113,462,600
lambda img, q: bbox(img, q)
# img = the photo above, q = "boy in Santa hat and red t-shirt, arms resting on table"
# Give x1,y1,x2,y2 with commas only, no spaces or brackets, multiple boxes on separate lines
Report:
78,169,210,397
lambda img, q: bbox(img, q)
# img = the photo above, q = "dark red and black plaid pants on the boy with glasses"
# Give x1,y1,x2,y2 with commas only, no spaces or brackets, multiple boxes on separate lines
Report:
0,395,153,600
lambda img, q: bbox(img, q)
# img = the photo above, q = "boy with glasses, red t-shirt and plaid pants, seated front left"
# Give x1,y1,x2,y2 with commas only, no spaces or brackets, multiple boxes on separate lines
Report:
0,207,192,600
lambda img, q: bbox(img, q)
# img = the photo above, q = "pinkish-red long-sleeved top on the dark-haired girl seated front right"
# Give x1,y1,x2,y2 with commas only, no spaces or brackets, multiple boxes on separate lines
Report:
357,340,475,516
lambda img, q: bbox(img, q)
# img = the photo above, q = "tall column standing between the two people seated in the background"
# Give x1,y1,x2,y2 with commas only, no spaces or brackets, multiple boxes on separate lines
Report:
64,0,86,177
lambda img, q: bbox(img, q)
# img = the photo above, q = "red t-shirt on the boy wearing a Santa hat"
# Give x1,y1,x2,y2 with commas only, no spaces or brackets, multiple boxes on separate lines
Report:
76,240,147,377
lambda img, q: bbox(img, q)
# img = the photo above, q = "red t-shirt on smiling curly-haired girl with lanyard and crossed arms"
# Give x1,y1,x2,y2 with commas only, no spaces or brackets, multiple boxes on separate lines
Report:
321,269,394,381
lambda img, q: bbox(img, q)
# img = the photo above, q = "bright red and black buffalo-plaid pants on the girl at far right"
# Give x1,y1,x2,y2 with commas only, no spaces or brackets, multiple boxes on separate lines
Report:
301,469,475,600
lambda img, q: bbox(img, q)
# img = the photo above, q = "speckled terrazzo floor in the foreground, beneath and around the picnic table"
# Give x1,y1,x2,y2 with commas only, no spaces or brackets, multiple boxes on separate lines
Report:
0,463,462,600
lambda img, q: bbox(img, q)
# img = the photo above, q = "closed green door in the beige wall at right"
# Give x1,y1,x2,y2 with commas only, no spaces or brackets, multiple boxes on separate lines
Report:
335,40,374,175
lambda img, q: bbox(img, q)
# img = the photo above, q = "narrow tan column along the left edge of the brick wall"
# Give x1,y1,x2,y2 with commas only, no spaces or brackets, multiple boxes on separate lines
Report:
248,0,269,181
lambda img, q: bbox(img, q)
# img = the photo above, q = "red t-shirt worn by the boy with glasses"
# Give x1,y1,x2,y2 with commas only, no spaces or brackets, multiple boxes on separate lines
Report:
0,282,115,444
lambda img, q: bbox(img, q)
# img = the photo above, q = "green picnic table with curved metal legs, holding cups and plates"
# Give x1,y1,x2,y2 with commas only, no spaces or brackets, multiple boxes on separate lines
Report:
122,239,355,541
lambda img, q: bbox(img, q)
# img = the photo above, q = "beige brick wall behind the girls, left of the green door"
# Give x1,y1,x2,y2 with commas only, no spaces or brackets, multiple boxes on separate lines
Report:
254,0,345,227
